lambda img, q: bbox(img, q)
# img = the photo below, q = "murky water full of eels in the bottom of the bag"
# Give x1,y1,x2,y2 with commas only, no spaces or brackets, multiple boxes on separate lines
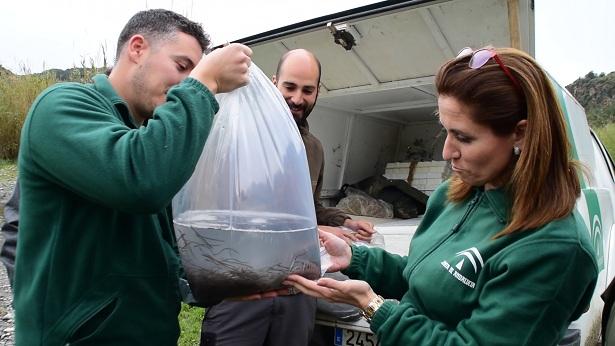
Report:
174,210,320,305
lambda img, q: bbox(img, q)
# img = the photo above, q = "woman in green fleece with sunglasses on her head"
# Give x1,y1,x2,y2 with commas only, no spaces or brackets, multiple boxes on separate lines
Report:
286,48,598,346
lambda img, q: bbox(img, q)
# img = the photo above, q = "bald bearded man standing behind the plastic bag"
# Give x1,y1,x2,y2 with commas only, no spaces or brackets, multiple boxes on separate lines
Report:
201,50,374,346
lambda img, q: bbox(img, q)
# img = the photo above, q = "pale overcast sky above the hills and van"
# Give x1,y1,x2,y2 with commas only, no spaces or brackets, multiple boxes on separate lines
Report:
0,0,615,85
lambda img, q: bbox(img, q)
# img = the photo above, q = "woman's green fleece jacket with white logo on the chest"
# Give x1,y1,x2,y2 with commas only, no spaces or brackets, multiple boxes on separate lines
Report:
345,183,598,346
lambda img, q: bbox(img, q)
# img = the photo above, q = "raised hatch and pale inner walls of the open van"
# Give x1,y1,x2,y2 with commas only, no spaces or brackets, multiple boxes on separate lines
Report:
240,0,534,204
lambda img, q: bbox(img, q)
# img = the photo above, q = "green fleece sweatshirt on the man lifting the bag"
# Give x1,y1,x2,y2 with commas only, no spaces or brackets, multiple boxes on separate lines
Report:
14,75,218,345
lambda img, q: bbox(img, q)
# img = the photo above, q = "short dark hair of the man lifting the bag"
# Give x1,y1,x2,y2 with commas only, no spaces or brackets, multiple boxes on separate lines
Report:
115,9,211,59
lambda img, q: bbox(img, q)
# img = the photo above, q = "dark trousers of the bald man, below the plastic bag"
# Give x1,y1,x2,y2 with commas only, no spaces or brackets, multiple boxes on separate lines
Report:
201,294,316,346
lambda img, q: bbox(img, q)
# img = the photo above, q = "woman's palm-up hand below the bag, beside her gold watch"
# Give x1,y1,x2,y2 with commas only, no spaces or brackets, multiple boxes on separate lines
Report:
284,274,376,309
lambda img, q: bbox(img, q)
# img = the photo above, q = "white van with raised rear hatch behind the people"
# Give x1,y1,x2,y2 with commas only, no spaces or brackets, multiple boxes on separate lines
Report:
239,0,615,345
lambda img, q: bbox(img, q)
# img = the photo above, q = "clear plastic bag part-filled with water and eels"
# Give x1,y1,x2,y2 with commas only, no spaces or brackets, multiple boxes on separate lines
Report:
173,64,320,305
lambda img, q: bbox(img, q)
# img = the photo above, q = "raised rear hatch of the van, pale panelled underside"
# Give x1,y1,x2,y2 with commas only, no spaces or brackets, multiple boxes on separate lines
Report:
238,0,534,123
